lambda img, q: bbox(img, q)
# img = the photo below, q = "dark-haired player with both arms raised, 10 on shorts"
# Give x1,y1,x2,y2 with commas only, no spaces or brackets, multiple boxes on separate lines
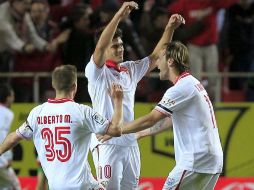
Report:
85,1,184,190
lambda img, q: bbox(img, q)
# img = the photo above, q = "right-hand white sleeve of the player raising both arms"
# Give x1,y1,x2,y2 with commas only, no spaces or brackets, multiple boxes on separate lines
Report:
126,57,150,82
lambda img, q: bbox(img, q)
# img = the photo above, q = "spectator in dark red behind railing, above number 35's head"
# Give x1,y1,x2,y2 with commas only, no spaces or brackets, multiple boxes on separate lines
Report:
13,0,70,102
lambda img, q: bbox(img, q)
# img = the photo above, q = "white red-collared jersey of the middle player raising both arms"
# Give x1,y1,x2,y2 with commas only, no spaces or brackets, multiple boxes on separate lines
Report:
85,56,150,149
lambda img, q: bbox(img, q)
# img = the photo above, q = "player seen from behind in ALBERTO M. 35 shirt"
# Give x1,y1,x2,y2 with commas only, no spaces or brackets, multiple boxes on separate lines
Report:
0,65,123,190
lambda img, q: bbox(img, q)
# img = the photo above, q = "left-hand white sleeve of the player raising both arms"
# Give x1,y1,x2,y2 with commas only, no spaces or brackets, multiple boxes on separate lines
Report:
85,55,104,82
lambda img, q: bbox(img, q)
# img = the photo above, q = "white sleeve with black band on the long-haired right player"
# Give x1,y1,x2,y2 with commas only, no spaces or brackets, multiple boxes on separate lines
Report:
155,87,190,117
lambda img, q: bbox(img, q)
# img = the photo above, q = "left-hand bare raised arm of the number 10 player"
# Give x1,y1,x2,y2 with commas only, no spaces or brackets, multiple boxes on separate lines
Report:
93,1,138,67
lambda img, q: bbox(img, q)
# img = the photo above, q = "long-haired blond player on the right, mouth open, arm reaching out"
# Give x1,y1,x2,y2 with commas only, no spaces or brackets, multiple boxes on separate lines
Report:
122,42,223,190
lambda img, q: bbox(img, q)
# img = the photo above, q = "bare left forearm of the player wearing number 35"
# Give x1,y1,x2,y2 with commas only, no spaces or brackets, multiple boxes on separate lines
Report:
0,131,23,155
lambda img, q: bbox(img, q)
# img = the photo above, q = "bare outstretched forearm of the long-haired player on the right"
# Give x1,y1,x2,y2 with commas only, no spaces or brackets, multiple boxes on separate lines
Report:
122,110,166,134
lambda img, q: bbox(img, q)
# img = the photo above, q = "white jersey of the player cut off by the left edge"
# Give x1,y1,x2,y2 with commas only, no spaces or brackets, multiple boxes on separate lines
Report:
0,104,14,168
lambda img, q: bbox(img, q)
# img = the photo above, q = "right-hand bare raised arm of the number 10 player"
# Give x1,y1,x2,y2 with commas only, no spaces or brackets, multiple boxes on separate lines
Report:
148,14,185,73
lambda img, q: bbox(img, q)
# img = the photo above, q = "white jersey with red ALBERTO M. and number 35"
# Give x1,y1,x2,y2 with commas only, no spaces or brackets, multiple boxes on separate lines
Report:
16,99,109,190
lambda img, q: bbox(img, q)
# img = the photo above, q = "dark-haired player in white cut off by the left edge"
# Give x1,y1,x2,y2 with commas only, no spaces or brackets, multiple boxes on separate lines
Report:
0,84,21,190
